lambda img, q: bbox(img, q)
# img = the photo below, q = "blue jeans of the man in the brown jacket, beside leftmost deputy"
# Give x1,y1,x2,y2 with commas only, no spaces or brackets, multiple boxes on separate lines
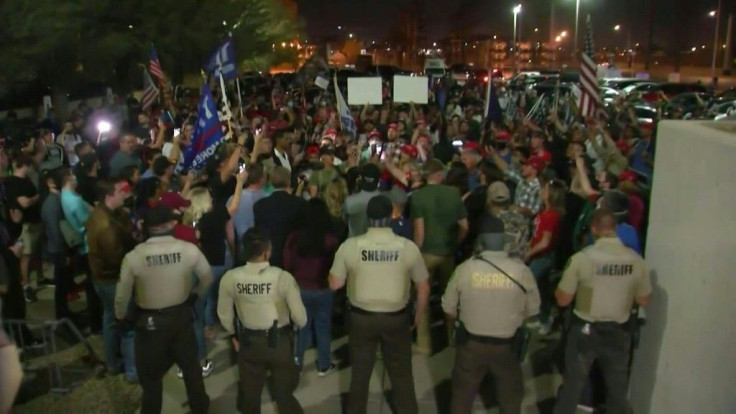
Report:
95,283,138,381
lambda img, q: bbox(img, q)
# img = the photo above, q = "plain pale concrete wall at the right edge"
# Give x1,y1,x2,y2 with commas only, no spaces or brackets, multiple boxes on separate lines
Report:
630,121,736,414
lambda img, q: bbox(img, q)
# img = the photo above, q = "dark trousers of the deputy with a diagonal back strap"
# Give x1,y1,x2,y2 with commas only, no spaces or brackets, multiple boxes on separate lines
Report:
452,339,524,414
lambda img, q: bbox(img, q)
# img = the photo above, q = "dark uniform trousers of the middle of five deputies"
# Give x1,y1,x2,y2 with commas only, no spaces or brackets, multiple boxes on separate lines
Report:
348,308,418,414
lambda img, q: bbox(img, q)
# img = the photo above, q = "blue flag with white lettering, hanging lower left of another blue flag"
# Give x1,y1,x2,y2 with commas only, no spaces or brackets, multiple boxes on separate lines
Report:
181,83,225,171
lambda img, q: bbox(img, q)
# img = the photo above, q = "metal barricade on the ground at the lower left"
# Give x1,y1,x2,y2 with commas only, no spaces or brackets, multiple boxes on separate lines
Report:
2,318,104,393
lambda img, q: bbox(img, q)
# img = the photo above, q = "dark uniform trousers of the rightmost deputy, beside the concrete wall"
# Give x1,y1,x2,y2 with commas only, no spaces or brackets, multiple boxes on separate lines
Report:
554,318,631,414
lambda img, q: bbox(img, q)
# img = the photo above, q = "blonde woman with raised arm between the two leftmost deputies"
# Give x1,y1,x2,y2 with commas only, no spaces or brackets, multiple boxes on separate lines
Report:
178,171,248,378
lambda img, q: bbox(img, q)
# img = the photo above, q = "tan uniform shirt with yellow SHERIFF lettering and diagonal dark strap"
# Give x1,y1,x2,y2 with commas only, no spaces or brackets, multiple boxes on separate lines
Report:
442,251,539,338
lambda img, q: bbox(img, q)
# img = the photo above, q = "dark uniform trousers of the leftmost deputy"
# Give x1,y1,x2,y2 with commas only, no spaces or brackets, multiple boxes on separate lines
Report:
135,305,210,414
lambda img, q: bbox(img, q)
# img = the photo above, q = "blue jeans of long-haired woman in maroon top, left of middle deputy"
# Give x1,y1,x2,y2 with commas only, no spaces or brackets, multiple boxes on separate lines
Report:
296,289,333,370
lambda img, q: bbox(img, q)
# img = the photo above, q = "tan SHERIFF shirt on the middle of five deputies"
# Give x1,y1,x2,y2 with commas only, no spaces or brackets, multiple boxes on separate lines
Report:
330,228,429,312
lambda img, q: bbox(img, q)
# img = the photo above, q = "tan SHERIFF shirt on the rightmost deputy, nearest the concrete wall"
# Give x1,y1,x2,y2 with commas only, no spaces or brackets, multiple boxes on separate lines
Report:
558,237,652,323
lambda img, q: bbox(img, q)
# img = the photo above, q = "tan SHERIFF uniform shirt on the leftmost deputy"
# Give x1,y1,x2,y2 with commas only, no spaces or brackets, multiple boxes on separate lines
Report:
115,236,212,319
